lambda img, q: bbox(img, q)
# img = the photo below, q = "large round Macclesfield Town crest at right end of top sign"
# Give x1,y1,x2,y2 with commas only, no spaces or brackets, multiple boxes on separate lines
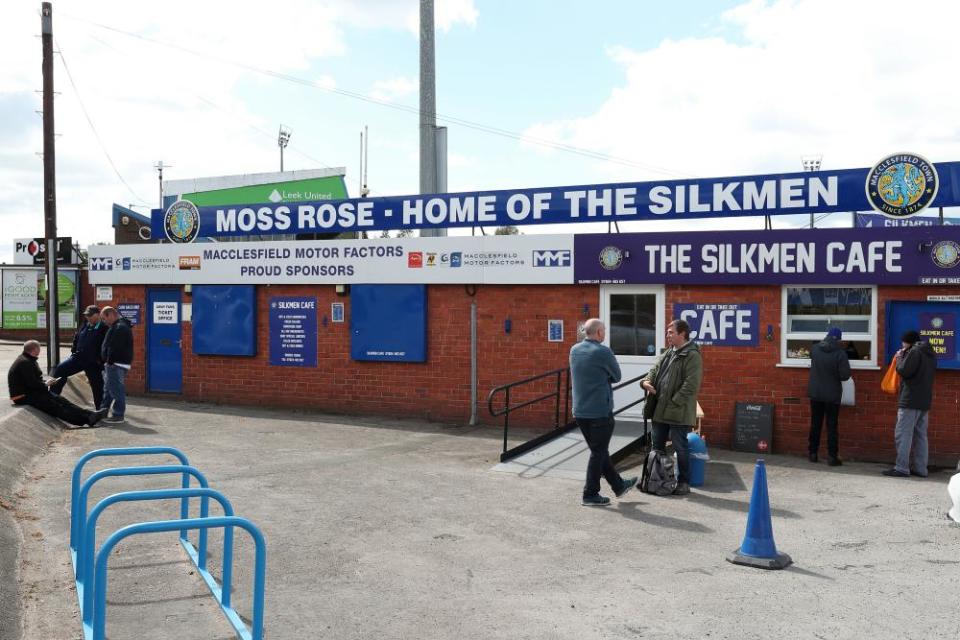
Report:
865,153,940,218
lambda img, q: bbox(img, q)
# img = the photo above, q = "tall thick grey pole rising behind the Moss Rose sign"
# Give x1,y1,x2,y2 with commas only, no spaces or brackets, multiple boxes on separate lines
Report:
420,0,447,238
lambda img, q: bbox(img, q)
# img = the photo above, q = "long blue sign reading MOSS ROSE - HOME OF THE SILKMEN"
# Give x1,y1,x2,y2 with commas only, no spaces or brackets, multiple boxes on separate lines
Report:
152,153,960,242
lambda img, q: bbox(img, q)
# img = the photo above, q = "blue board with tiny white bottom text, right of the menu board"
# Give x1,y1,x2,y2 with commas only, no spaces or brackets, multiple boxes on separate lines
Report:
350,284,427,362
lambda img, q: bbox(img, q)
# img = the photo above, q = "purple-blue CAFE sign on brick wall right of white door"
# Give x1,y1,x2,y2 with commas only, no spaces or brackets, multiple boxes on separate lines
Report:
673,303,760,347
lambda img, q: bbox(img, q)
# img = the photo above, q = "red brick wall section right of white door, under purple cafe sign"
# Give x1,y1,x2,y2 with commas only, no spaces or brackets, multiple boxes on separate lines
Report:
666,286,960,466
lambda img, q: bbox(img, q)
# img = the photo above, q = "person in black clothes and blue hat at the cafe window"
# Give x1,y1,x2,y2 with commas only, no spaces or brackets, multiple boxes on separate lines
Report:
807,327,850,467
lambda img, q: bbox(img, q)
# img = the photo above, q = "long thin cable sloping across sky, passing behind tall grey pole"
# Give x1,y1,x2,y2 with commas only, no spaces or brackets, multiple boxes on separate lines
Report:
64,15,696,178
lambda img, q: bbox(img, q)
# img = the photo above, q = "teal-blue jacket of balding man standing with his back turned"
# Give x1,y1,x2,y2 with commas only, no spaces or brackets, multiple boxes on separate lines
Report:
570,339,621,419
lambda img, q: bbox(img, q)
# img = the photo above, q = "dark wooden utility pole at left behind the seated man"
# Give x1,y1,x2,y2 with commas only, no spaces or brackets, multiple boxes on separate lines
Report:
40,2,60,373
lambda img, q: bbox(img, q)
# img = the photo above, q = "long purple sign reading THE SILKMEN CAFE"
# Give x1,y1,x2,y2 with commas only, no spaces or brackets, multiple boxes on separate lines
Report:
574,227,960,285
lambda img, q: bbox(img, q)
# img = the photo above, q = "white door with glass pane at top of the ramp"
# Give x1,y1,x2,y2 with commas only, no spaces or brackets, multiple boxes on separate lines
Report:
600,285,666,418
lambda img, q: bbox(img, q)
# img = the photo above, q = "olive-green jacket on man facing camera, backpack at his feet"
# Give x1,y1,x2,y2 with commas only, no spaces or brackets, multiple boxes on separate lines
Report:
640,341,703,427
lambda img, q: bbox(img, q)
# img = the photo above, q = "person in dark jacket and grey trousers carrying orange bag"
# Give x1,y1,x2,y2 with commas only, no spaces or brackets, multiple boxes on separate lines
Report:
883,331,937,478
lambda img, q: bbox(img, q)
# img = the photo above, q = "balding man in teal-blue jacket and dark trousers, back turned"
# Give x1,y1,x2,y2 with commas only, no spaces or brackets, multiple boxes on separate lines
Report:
570,318,637,507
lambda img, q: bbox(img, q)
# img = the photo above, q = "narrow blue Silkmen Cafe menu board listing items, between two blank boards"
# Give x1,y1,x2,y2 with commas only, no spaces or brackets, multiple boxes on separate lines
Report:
270,296,317,367
